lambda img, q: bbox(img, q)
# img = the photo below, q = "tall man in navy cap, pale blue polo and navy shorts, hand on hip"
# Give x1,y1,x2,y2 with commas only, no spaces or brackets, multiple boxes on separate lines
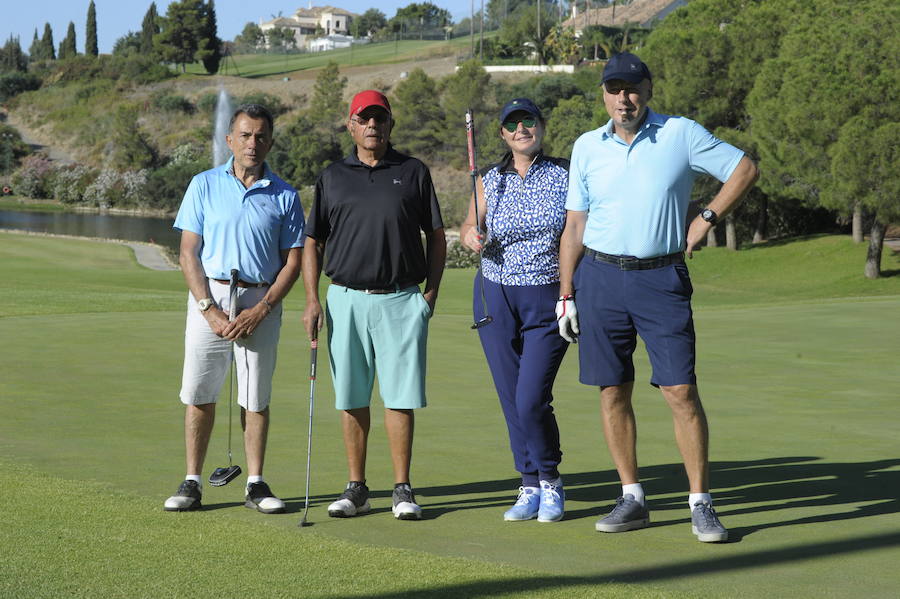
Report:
557,52,758,542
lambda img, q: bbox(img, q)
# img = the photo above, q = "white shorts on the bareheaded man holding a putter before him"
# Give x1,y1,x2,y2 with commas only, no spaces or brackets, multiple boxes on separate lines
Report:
180,280,282,412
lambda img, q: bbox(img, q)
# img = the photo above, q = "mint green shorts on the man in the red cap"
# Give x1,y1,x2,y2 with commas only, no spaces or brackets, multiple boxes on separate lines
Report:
325,284,431,410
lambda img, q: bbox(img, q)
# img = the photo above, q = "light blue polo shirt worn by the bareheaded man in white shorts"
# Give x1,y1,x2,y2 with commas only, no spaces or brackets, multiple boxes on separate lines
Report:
174,158,304,283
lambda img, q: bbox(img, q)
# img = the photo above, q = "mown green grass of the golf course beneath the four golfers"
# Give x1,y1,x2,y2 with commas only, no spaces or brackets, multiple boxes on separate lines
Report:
0,233,900,599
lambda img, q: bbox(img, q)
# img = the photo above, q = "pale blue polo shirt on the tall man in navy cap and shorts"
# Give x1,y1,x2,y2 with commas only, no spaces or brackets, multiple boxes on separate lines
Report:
566,109,744,258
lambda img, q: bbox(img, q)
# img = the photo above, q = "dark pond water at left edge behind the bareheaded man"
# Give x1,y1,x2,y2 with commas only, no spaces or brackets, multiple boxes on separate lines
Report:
0,210,181,252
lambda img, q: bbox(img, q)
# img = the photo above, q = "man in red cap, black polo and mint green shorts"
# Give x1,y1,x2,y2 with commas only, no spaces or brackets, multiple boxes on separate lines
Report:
303,90,447,520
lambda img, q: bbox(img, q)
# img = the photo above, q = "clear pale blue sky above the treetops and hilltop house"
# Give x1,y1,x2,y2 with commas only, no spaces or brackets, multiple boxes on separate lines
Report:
0,0,474,53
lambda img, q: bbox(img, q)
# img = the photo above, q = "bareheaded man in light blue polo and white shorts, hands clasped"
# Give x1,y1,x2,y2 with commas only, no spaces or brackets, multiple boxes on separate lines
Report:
164,104,305,514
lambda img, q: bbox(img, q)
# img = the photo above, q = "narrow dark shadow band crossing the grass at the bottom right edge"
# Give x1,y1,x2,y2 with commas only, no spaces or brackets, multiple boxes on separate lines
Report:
333,532,900,599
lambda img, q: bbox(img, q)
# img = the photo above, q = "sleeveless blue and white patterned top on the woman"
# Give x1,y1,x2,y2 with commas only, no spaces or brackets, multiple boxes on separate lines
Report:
481,153,569,285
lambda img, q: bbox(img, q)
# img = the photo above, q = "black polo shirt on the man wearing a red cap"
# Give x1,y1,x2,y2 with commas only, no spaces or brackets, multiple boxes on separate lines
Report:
306,146,444,289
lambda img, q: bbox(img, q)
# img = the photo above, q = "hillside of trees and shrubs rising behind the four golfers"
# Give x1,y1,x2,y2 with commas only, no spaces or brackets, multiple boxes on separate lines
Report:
0,0,900,277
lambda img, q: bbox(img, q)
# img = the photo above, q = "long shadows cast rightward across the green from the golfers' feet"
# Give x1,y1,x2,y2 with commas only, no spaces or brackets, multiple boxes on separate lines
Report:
285,456,900,542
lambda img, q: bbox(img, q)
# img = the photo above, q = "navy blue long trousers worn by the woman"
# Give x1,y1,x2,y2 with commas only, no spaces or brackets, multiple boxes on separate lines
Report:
473,275,569,487
